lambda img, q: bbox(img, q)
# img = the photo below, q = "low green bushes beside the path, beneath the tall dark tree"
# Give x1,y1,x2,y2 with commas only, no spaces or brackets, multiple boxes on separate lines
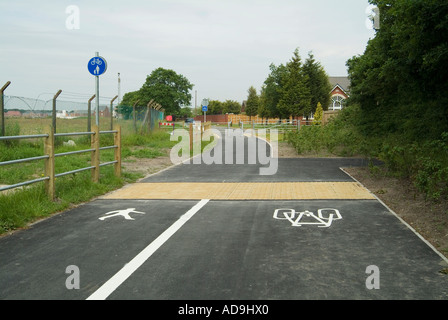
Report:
288,105,448,200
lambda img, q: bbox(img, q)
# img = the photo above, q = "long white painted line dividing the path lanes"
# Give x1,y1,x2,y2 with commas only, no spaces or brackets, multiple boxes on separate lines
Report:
87,200,210,300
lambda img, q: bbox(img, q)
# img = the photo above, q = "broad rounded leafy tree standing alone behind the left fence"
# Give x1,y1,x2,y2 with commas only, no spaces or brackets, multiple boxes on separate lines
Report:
139,68,193,114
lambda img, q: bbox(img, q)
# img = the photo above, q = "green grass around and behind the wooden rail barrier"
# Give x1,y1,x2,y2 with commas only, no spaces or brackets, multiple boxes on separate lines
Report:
0,119,191,234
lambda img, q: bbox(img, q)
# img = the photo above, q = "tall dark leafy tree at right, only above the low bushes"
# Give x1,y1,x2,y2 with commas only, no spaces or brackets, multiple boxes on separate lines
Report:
347,0,448,140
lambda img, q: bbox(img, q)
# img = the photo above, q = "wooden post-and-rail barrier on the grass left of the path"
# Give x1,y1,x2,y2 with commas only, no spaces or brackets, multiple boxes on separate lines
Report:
0,126,121,201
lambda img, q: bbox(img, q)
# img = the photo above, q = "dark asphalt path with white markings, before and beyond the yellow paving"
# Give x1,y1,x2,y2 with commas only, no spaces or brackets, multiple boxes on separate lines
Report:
0,128,448,300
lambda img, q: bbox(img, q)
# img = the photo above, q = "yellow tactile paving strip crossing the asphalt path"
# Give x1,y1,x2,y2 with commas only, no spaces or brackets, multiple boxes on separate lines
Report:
102,182,375,200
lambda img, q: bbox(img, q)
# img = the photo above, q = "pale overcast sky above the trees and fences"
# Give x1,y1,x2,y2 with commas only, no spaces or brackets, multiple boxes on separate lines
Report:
0,0,374,105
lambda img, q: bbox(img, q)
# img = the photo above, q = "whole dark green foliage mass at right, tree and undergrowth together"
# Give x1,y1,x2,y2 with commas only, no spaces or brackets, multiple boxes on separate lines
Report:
338,0,448,200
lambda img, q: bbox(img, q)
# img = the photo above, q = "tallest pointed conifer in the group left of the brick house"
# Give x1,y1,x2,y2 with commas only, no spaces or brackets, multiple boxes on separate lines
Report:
278,49,313,117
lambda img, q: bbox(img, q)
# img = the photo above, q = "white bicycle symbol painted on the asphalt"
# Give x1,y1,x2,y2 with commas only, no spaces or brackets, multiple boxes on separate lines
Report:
273,209,342,228
